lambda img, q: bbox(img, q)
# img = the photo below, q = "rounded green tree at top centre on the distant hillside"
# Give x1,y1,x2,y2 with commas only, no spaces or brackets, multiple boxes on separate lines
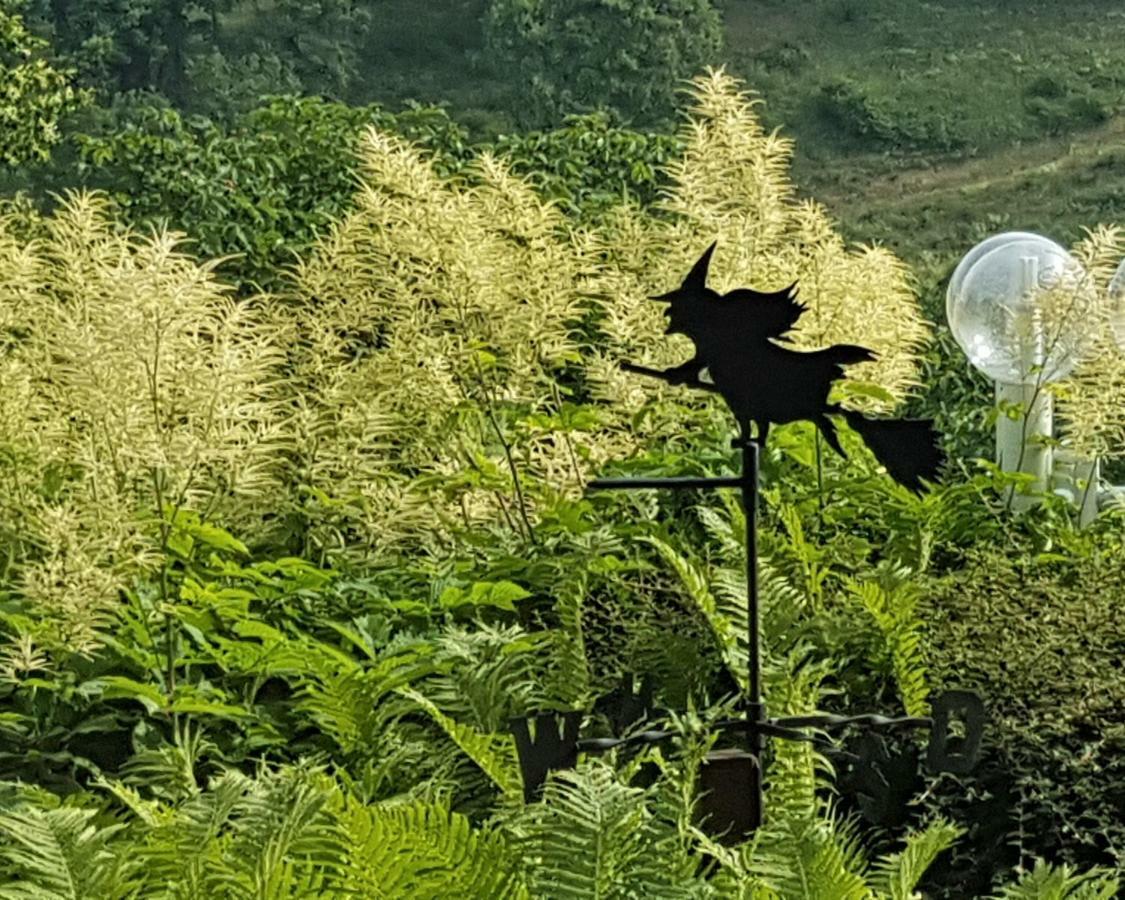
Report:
485,0,722,125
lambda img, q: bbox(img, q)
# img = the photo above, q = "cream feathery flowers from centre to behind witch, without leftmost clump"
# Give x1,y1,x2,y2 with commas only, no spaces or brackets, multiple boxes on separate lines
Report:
294,72,929,552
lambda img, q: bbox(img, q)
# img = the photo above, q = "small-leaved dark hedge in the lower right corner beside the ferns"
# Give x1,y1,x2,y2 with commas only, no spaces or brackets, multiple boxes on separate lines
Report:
925,535,1125,892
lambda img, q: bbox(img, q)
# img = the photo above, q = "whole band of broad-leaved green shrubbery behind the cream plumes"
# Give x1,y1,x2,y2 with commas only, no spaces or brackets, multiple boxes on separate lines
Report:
13,98,681,290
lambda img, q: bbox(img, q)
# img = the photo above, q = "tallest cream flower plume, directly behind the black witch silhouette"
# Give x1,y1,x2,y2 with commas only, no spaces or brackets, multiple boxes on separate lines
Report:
595,71,930,413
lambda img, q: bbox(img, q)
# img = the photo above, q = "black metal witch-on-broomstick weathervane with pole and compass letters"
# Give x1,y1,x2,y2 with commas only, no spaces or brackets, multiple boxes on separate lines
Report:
512,243,984,839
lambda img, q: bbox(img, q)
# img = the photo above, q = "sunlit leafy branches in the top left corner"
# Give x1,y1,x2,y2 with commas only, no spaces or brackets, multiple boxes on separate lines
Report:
0,0,88,167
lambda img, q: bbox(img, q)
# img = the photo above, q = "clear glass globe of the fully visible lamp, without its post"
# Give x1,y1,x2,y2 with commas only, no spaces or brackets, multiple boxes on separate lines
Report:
950,236,1098,385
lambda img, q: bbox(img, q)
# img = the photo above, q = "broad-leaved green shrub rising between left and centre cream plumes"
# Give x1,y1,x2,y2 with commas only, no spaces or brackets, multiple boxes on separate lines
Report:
59,98,467,289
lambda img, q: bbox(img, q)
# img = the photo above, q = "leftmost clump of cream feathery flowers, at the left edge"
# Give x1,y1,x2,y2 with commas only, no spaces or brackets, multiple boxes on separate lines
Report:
0,195,282,650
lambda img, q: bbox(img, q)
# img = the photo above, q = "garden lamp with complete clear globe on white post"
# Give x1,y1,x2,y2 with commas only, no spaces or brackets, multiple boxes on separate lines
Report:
946,232,1087,509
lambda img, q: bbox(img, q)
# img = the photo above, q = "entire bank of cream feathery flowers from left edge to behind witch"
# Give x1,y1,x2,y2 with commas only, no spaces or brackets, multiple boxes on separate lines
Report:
0,72,928,589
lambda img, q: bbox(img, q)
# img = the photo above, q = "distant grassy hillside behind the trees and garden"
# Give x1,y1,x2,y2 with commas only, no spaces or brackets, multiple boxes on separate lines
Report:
355,0,1125,269
